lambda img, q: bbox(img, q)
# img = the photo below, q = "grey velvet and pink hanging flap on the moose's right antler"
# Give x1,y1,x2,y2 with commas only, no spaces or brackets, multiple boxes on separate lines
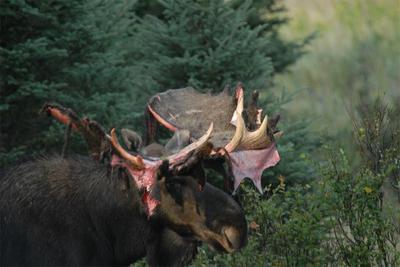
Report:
148,87,280,192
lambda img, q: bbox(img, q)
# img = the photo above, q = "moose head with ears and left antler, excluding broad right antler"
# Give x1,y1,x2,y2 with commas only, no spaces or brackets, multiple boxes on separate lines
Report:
43,104,247,255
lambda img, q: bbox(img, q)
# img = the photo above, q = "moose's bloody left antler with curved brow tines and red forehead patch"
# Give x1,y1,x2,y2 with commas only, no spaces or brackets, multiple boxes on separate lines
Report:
41,104,213,215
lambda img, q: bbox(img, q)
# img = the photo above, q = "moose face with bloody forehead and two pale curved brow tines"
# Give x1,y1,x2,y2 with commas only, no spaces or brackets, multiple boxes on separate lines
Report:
110,124,247,252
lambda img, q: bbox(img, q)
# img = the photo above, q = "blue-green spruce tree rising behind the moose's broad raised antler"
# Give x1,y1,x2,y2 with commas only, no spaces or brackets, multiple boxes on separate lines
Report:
125,0,318,183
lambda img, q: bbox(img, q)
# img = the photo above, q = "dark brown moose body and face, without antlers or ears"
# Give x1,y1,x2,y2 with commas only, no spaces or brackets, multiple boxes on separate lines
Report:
0,157,247,266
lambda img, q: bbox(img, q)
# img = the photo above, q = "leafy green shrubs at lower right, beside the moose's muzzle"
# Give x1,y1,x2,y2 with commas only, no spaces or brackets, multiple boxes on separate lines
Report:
193,99,400,266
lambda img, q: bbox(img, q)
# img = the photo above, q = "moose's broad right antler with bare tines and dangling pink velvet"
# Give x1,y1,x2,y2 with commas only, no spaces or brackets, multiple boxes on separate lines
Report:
147,83,282,194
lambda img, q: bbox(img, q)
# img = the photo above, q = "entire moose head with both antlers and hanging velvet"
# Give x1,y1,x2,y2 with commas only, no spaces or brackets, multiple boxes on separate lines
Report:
39,84,282,266
